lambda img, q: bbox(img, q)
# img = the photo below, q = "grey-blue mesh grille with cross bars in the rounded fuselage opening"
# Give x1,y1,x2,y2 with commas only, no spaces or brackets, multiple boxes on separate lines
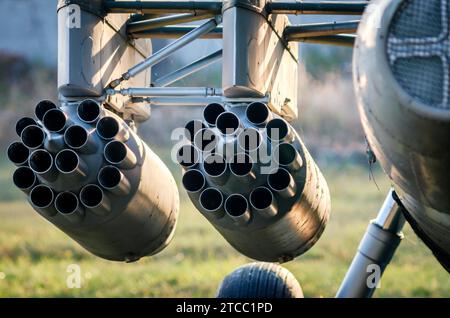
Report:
388,0,450,110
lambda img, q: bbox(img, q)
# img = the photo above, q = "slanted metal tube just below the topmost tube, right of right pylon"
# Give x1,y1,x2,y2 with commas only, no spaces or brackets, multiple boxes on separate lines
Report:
283,20,360,41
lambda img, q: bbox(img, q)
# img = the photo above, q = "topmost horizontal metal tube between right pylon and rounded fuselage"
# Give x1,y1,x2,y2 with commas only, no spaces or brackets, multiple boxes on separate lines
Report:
266,1,369,15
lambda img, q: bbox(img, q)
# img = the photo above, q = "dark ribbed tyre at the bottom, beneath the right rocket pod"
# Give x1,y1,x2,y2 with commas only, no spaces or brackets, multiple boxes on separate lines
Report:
216,263,303,298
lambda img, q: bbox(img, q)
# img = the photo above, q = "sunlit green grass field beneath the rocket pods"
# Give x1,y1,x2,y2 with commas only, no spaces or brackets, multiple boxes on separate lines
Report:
0,167,450,297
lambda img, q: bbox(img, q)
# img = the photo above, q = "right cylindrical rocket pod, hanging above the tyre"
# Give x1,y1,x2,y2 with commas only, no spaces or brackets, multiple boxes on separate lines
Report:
178,102,330,262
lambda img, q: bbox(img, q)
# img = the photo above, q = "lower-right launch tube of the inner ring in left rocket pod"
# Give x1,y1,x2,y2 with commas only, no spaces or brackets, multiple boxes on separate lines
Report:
55,149,89,180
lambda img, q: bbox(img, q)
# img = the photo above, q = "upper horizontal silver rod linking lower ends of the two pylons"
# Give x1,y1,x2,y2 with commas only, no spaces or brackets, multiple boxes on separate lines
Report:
115,87,222,97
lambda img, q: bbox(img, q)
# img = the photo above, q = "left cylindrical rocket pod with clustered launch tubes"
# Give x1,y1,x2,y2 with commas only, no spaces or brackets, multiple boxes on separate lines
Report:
7,100,179,262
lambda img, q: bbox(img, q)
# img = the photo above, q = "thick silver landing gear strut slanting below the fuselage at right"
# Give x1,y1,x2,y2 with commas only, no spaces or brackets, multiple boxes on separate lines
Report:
336,190,405,298
